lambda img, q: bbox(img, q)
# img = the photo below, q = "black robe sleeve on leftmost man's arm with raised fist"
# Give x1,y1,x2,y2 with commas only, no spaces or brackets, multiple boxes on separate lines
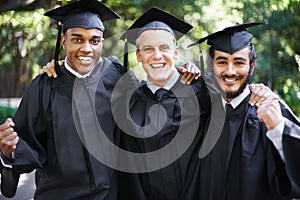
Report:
13,75,51,174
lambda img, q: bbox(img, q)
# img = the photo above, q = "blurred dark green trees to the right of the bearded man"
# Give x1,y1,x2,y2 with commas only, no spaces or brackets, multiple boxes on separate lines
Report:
244,0,300,116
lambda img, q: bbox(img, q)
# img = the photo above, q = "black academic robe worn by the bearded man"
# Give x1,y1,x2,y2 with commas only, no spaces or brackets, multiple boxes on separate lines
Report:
199,95,299,200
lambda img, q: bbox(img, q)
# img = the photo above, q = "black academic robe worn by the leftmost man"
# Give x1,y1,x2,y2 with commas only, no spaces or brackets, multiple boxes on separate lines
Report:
9,57,124,200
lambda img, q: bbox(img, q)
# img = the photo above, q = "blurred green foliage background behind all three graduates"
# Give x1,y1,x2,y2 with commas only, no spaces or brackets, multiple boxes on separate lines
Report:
0,0,300,116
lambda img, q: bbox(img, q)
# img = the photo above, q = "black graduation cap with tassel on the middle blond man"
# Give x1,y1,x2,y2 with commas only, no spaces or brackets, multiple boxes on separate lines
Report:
121,7,193,70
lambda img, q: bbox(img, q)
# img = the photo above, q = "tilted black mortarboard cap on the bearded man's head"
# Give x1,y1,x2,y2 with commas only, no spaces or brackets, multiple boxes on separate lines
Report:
188,22,263,54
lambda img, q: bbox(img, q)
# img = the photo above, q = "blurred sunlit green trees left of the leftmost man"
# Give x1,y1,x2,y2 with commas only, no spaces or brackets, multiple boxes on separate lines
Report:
0,9,56,97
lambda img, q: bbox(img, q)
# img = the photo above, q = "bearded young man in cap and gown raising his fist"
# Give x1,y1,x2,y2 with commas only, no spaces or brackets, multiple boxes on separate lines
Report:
190,23,300,200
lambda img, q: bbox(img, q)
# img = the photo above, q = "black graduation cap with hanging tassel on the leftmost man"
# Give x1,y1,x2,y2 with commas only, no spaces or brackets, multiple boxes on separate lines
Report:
44,0,120,72
